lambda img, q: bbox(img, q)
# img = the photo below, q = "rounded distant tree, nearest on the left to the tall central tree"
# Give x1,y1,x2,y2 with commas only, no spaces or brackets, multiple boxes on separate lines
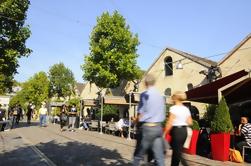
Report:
49,63,76,98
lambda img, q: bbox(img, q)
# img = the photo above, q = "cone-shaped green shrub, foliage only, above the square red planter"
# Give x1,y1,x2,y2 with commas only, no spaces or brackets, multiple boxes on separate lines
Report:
211,97,233,133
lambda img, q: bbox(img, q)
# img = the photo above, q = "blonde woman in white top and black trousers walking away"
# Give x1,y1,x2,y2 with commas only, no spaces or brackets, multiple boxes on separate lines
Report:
164,91,193,166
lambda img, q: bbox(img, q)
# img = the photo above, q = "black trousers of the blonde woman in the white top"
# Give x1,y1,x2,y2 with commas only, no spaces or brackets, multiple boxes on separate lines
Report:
171,127,188,166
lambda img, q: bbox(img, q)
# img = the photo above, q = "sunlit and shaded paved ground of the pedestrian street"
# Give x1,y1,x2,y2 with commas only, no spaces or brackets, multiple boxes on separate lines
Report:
0,120,251,166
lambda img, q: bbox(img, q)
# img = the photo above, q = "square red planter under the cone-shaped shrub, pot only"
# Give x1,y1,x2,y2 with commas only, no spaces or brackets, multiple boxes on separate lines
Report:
210,133,230,161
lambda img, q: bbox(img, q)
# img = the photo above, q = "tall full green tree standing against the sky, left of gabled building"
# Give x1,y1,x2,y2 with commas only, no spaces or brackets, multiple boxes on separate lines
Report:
82,11,140,88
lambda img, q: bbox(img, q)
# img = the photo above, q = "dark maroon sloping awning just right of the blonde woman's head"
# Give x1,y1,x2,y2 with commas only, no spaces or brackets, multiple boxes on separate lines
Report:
186,70,248,104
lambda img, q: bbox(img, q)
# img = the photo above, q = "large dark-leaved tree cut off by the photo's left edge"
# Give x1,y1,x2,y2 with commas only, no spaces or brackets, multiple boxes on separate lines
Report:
0,0,31,94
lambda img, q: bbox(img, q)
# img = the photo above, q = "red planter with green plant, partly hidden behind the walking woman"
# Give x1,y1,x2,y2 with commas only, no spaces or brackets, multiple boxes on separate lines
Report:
184,120,200,155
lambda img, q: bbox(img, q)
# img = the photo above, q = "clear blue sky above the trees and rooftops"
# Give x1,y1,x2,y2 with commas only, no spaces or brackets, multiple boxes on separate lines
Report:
15,0,251,83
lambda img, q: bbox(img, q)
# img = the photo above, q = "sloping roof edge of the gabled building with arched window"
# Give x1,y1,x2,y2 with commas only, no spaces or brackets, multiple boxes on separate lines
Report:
145,47,217,74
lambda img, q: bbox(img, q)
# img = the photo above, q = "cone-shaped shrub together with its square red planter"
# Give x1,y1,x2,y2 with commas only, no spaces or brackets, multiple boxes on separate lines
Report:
210,98,233,161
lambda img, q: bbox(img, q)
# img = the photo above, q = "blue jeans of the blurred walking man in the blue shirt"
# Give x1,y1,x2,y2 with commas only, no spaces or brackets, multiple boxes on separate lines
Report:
133,125,165,166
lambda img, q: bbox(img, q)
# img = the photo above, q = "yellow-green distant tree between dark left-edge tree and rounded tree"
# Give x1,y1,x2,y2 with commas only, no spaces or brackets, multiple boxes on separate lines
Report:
10,72,49,107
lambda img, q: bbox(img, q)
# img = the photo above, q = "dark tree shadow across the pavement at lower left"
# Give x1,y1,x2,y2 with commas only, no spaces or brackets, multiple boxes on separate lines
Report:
0,141,131,166
